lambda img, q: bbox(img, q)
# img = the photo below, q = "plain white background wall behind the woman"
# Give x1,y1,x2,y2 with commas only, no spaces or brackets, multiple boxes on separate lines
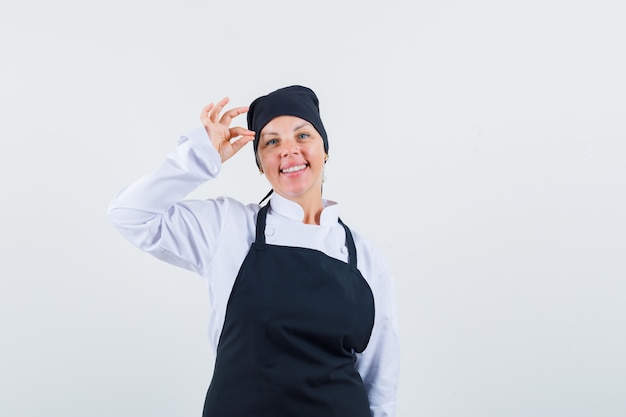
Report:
0,0,626,417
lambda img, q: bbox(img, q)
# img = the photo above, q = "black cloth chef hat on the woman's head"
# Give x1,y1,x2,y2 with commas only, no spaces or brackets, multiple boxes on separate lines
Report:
248,85,328,165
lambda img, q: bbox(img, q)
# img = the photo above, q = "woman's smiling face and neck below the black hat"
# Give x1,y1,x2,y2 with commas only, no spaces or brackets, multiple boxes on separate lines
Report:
257,116,327,210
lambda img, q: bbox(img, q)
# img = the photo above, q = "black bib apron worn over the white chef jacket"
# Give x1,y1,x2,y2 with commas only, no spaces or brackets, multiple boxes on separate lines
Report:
203,204,374,417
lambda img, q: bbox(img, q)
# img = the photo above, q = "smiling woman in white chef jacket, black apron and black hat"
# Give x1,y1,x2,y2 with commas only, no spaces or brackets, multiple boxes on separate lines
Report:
109,85,399,417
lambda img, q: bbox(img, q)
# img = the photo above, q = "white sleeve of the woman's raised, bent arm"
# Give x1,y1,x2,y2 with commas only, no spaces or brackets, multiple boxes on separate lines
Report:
108,128,228,274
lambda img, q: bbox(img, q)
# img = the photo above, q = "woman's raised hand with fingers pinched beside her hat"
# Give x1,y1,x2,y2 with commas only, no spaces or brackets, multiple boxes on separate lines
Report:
200,97,254,162
